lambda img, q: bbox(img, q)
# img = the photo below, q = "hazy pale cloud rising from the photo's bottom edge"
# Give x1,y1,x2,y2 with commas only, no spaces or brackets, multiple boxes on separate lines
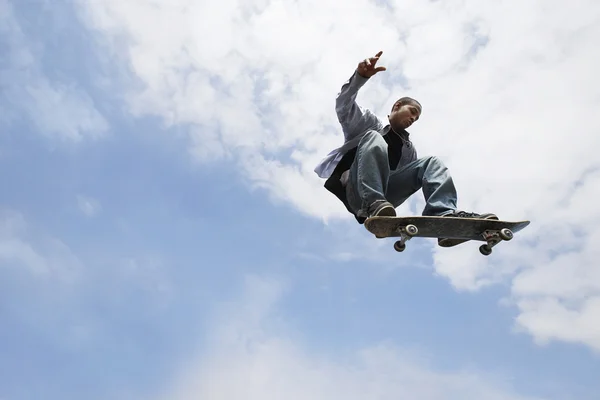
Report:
160,277,548,400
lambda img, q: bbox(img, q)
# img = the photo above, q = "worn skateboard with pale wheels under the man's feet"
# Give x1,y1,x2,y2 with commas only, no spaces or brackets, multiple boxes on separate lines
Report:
364,216,530,256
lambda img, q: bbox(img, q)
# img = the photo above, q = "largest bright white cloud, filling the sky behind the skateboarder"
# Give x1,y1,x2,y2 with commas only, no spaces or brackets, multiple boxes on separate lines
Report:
80,0,600,347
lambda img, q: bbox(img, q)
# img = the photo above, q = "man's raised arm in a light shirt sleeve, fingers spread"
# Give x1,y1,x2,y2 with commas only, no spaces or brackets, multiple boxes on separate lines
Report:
335,51,385,140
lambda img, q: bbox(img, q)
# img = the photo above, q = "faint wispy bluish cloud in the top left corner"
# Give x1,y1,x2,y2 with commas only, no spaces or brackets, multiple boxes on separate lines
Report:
0,0,108,142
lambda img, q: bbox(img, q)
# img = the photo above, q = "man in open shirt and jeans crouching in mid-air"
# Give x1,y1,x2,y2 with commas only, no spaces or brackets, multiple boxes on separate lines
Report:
315,51,498,247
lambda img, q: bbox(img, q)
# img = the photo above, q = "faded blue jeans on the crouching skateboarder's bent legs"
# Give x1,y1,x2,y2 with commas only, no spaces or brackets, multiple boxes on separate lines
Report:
346,131,457,217
